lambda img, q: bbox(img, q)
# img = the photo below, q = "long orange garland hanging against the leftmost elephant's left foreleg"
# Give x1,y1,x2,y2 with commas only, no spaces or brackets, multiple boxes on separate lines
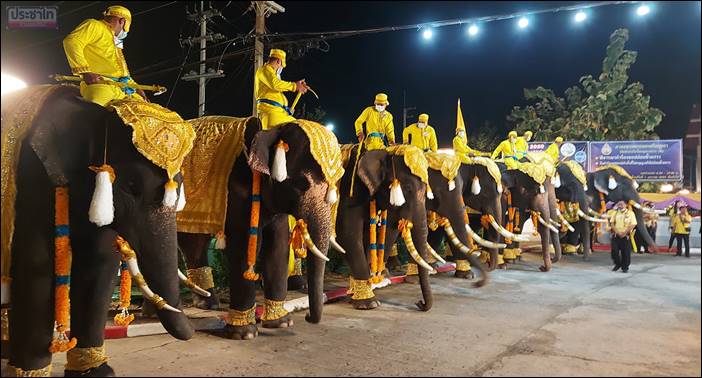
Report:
49,187,77,353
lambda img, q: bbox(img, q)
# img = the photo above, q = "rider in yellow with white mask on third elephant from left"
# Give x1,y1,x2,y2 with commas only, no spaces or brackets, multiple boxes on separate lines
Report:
354,93,395,151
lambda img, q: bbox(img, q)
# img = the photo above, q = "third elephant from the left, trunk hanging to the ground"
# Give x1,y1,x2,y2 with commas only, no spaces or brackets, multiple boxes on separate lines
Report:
336,145,433,311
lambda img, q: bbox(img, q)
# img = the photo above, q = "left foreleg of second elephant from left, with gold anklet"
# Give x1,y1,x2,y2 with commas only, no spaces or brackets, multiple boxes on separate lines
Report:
224,227,261,340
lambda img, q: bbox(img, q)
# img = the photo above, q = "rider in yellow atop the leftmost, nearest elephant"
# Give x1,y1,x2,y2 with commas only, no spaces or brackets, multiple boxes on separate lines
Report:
63,5,148,106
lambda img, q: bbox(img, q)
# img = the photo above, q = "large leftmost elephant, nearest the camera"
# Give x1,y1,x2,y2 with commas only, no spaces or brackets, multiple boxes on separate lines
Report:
3,86,194,376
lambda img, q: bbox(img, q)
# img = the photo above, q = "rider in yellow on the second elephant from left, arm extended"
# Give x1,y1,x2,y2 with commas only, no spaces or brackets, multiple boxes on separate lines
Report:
254,49,307,130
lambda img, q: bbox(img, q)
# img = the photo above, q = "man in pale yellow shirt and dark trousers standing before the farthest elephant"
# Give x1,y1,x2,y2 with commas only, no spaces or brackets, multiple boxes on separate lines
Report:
608,201,636,273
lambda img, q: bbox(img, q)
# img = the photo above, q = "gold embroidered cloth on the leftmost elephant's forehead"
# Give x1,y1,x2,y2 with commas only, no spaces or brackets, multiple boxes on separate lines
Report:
107,99,195,179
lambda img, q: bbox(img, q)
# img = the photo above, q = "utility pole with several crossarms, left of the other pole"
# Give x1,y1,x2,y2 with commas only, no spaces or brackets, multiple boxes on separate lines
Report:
180,1,225,117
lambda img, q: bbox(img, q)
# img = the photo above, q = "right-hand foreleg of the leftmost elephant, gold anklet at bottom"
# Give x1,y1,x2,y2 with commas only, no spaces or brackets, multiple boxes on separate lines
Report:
65,228,119,376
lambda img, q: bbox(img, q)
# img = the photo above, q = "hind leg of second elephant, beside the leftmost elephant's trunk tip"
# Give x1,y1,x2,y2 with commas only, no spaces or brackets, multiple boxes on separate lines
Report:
178,232,220,310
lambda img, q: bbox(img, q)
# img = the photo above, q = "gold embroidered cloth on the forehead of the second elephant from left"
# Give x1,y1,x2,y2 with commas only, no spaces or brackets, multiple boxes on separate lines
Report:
295,119,344,185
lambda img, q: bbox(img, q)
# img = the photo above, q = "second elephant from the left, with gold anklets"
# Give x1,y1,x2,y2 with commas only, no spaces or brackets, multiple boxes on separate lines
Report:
178,117,340,340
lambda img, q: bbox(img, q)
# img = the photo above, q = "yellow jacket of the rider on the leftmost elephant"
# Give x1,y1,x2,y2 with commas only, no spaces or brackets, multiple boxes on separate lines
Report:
63,18,133,82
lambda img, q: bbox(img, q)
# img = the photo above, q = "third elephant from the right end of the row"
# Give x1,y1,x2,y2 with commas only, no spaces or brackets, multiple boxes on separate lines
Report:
498,163,561,272
